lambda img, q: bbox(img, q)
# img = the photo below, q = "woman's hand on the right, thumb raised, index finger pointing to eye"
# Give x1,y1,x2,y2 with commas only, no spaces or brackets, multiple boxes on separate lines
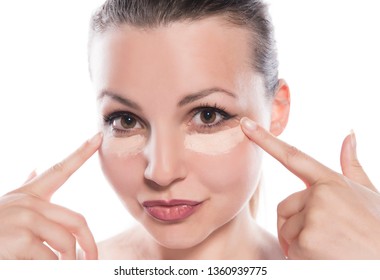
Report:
241,118,380,259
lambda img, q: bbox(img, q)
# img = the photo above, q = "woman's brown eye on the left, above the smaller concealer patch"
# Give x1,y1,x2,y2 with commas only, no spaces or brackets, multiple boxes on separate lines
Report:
104,112,143,135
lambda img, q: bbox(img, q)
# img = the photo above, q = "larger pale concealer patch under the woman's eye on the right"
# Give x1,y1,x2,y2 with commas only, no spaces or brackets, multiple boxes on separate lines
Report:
185,125,245,155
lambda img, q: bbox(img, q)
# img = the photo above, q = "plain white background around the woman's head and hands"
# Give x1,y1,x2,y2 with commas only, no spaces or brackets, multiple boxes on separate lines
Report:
0,0,380,241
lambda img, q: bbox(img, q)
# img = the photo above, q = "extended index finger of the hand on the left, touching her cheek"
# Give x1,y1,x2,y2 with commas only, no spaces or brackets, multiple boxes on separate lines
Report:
16,133,102,200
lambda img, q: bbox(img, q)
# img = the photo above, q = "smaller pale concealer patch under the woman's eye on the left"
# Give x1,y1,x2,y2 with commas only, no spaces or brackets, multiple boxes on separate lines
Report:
102,134,147,157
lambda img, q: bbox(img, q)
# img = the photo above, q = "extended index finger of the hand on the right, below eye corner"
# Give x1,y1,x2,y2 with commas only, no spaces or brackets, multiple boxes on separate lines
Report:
241,117,335,187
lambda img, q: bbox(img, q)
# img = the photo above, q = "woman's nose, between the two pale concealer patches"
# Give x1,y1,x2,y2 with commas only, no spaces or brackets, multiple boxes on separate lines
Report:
144,127,187,187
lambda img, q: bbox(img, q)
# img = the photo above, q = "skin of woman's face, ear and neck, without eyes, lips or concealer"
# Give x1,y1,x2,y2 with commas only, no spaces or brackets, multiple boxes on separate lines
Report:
91,17,289,259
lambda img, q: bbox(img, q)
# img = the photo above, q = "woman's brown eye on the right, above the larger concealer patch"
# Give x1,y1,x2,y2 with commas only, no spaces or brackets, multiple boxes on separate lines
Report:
192,107,231,127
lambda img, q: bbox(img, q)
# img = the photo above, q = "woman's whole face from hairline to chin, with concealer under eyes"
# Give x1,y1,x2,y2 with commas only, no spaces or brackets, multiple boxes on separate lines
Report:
90,17,270,249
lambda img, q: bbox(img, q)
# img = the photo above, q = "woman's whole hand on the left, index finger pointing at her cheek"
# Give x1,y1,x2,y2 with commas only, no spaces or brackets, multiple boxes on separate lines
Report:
0,134,102,260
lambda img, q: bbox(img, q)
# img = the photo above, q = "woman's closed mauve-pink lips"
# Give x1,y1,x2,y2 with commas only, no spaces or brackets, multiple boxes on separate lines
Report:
142,199,201,222
